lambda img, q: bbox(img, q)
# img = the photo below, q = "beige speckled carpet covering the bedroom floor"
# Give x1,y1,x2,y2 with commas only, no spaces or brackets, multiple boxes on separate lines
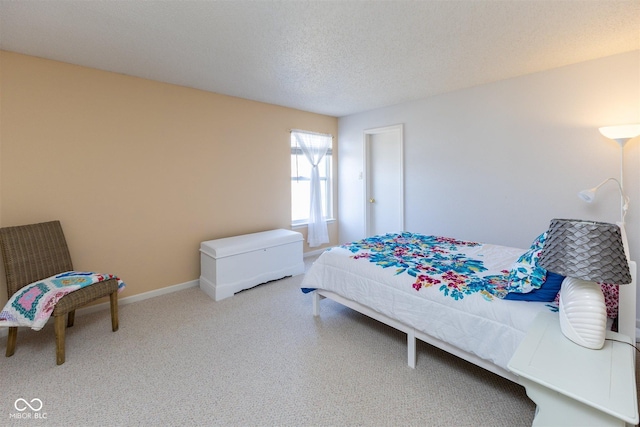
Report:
0,260,535,427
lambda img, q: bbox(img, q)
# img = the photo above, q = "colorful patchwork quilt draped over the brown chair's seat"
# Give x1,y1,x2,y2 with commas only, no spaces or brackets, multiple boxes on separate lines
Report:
0,271,125,331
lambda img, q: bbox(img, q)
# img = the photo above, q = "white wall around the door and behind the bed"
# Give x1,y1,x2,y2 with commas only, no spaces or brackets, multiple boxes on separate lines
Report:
338,51,640,259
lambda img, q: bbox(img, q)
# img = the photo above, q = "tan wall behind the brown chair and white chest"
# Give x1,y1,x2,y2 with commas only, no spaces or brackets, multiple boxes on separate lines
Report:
0,51,338,305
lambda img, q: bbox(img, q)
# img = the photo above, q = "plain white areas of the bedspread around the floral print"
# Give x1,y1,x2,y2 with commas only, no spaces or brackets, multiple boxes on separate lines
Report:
301,239,555,369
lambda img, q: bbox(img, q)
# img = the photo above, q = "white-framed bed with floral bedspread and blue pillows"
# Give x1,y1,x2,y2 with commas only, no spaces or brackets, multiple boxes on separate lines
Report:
301,232,636,381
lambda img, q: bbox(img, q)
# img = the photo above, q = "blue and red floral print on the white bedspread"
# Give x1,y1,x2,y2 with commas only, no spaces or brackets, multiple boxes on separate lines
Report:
341,232,509,301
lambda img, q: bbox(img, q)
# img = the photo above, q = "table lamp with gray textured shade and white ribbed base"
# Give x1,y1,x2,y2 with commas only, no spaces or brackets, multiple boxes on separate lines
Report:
538,219,631,350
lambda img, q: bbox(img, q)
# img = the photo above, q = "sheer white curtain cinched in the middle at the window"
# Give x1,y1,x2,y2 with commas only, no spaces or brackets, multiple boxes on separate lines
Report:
293,131,331,247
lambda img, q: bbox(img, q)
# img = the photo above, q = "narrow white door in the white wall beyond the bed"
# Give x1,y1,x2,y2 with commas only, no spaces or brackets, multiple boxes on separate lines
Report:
364,125,404,236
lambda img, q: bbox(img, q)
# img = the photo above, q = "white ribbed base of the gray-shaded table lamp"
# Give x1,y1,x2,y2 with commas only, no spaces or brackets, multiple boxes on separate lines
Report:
560,277,607,350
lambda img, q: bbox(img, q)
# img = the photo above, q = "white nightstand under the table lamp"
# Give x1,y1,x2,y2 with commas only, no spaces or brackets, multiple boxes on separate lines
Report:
508,312,638,427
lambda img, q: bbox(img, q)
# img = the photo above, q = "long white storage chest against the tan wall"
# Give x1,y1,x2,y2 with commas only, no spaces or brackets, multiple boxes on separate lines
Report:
200,229,304,301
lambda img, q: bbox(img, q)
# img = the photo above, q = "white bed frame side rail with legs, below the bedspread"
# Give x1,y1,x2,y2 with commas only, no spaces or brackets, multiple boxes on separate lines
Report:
313,289,518,382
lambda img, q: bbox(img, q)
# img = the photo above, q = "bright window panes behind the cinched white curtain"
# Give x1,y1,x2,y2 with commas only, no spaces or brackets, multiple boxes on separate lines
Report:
291,130,333,225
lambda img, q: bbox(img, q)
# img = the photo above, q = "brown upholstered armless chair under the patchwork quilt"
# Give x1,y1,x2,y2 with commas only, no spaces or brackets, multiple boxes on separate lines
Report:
0,221,118,365
